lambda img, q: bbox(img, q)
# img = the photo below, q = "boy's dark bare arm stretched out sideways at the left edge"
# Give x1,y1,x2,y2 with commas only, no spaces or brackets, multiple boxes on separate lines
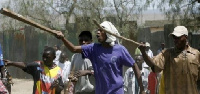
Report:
3,60,26,69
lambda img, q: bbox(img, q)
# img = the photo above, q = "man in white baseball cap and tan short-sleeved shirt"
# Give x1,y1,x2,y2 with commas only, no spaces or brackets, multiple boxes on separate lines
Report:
139,26,200,94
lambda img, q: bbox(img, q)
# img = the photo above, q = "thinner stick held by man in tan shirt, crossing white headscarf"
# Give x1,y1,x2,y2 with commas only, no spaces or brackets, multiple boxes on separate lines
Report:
93,20,140,46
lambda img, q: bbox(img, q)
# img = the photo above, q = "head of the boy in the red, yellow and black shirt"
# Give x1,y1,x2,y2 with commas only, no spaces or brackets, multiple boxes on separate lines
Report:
42,51,55,67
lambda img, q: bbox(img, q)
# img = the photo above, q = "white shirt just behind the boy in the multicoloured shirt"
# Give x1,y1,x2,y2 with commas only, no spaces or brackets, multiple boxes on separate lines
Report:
55,61,71,83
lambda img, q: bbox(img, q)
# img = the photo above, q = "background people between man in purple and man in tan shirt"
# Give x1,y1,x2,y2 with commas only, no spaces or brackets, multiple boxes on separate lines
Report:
124,42,166,94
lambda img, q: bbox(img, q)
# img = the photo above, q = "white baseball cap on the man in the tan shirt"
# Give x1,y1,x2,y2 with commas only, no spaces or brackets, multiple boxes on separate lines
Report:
170,26,188,37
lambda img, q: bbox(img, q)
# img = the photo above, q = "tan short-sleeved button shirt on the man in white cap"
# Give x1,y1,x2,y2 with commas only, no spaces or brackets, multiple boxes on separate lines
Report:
153,46,200,94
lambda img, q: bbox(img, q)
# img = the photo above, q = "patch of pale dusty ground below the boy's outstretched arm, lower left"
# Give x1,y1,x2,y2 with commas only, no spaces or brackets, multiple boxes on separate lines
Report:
11,79,33,94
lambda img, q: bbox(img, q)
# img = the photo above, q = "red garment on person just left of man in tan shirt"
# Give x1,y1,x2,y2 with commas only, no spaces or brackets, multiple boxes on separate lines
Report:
148,72,157,94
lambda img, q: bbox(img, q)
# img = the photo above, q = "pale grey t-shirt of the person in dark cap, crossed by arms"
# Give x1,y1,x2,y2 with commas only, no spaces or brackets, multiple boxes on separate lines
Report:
71,53,95,93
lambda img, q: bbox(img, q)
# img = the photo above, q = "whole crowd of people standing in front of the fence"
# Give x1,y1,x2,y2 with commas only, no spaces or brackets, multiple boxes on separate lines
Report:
0,21,200,94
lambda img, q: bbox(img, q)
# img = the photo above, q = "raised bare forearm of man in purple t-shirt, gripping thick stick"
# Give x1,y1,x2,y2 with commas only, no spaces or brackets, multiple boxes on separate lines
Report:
55,31,82,53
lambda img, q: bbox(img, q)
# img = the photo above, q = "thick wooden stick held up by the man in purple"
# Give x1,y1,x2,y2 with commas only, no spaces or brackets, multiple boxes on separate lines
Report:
0,8,56,34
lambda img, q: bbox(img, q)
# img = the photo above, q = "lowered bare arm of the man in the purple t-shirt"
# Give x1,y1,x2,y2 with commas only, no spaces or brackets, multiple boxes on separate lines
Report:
132,63,144,94
